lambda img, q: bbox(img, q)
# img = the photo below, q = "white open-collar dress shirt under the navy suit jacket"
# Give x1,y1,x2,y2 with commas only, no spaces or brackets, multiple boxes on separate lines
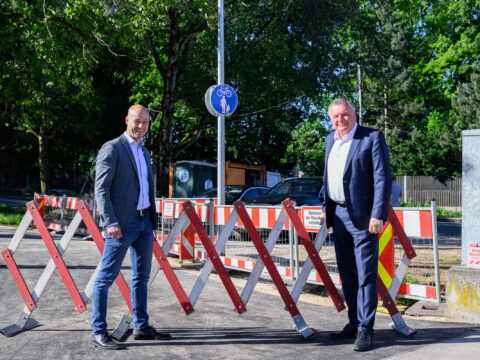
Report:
327,123,358,202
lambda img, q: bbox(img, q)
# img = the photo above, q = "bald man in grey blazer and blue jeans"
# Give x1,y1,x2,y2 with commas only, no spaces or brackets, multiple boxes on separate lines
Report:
91,104,171,349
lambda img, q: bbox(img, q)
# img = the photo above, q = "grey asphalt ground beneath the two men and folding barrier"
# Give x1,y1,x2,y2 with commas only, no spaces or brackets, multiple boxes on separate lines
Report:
0,226,480,360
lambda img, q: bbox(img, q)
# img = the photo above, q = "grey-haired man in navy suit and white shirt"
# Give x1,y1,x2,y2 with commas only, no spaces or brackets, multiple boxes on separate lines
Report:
324,98,392,351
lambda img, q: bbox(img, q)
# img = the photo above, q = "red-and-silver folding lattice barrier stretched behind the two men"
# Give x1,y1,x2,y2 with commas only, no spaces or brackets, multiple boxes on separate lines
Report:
1,200,432,339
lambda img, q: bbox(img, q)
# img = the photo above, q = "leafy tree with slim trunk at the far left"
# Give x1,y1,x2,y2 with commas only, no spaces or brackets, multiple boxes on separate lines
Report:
0,0,100,192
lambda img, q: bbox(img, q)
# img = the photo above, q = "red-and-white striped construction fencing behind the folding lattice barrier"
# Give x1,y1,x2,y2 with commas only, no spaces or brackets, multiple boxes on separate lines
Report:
36,195,440,302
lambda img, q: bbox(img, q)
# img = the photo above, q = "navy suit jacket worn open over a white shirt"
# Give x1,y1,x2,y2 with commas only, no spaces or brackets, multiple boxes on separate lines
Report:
324,125,392,229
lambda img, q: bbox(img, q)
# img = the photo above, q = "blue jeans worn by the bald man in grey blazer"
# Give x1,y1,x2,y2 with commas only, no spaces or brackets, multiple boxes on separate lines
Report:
92,215,154,334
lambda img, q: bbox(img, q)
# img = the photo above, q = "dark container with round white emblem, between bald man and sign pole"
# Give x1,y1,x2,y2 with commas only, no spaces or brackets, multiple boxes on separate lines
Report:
168,160,217,198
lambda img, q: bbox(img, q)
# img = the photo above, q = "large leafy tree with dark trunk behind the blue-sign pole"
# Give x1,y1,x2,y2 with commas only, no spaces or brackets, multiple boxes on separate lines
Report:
105,0,352,193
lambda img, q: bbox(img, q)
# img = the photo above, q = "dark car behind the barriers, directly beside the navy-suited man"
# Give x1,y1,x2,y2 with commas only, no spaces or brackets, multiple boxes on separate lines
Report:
242,176,324,206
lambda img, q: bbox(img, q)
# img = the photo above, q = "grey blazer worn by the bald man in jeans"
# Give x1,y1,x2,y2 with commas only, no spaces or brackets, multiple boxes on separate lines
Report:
95,134,157,232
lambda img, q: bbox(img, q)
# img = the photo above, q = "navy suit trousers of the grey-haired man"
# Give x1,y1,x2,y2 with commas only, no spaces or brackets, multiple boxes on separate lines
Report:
332,206,378,334
